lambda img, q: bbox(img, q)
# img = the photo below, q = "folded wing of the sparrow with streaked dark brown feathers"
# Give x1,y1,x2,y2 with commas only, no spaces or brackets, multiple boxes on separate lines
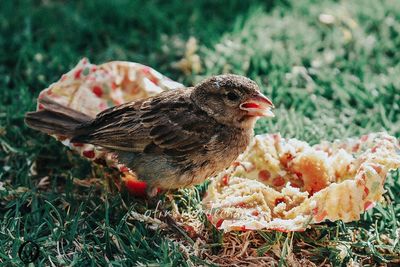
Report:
73,89,215,155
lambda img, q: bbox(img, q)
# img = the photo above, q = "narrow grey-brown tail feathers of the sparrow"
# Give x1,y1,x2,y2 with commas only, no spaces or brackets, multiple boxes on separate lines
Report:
25,97,93,137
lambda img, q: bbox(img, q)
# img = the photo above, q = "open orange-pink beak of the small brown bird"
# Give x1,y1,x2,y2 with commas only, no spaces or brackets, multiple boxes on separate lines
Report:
240,93,275,117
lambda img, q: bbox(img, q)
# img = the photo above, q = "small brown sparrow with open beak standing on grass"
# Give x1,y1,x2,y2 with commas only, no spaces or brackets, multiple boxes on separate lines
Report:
25,74,274,196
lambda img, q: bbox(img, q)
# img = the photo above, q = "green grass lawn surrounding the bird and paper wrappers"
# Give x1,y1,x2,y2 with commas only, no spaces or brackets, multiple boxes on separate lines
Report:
0,0,400,266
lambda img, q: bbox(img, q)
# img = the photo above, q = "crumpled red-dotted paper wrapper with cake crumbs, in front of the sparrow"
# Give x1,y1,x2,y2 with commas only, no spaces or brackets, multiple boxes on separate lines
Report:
203,133,400,232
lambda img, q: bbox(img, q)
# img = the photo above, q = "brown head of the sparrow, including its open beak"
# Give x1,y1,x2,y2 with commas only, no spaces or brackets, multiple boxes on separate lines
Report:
191,74,274,128
